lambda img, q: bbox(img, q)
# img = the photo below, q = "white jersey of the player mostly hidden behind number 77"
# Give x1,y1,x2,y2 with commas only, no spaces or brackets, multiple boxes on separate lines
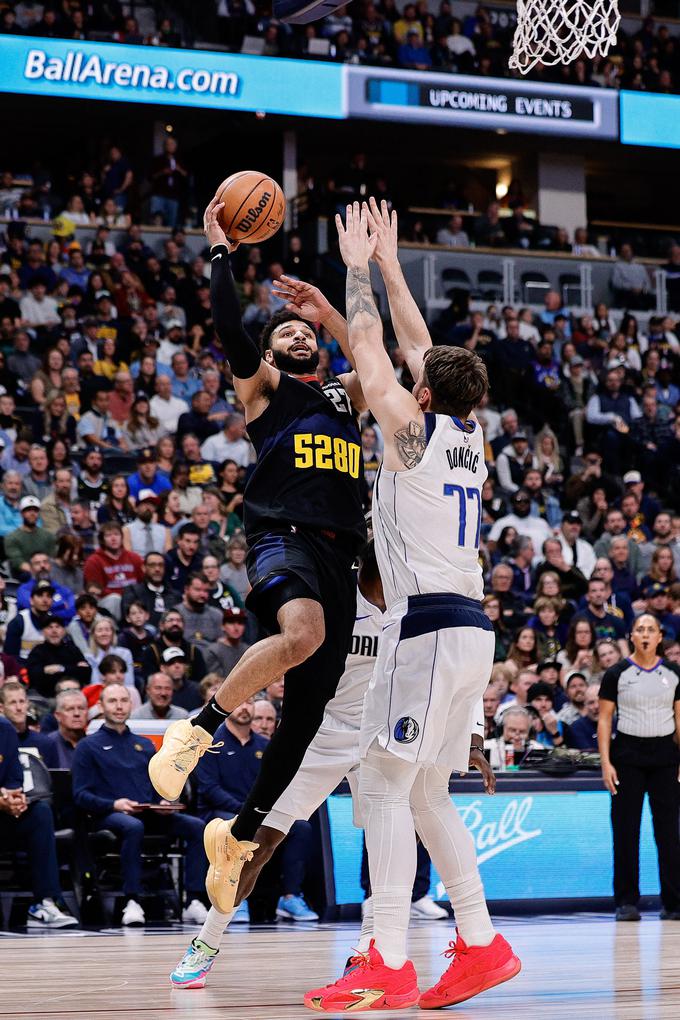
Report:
325,590,382,730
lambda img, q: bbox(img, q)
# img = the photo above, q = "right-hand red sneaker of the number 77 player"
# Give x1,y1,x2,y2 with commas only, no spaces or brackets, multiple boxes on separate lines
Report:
418,935,522,1010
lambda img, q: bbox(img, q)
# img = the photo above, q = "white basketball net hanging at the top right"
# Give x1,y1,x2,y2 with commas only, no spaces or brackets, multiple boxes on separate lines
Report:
510,0,621,74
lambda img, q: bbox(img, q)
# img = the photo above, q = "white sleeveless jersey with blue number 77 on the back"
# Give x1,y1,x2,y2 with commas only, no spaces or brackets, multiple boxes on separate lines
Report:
373,412,488,608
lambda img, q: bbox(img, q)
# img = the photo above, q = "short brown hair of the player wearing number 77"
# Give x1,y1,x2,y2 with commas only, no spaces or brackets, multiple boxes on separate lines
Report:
424,347,488,418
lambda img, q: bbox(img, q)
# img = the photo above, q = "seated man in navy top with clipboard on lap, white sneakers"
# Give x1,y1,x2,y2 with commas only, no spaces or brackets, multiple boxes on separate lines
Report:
72,683,208,926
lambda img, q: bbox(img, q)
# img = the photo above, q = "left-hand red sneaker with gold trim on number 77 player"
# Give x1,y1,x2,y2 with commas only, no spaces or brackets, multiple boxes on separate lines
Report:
304,939,420,1013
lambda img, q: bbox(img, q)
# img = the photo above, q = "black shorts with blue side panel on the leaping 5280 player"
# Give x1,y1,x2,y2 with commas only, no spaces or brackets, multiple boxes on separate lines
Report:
246,525,359,675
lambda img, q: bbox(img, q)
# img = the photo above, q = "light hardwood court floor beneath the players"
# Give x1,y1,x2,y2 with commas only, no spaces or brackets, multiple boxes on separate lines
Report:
5,914,680,1020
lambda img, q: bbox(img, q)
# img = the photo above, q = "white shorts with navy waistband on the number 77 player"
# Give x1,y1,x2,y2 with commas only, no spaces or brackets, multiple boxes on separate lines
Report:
359,594,494,772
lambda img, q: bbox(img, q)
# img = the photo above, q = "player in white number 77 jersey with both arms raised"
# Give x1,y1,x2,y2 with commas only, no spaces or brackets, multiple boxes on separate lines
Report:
305,203,520,1012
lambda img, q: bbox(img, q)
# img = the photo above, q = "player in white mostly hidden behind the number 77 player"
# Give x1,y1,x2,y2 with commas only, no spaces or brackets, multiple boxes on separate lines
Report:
170,543,495,988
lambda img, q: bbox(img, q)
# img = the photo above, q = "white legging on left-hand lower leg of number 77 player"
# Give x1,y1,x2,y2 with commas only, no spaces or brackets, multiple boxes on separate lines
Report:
359,744,419,969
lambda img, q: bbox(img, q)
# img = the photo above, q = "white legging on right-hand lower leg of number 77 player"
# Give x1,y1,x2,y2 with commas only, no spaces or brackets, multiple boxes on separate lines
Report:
411,766,495,946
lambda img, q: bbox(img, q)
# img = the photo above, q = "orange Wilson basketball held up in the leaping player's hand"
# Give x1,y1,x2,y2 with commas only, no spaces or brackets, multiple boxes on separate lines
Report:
217,170,285,245
